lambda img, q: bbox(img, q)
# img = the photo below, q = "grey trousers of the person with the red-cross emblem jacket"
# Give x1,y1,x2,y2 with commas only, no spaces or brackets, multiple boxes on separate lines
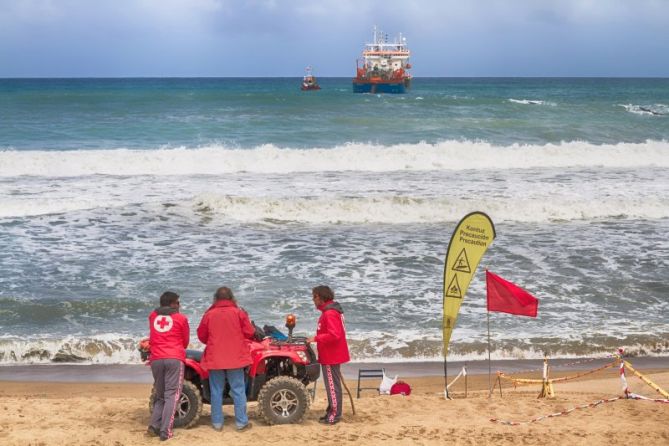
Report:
149,359,184,438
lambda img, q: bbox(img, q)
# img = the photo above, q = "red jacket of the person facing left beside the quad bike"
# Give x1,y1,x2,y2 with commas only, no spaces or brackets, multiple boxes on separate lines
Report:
314,301,351,365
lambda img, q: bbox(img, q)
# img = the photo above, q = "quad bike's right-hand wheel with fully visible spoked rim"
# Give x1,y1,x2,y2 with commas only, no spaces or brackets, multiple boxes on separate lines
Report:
258,376,309,425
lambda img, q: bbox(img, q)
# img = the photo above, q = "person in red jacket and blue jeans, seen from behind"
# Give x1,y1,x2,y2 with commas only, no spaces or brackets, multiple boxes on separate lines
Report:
197,287,255,431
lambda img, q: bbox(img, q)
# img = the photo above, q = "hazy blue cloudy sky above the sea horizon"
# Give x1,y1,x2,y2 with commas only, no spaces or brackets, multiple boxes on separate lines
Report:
0,0,669,77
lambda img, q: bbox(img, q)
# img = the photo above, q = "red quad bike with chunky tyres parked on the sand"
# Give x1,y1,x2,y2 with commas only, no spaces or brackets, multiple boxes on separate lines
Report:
139,314,320,428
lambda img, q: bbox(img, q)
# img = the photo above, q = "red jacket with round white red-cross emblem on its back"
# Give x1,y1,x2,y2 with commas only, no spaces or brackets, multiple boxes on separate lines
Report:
149,307,190,361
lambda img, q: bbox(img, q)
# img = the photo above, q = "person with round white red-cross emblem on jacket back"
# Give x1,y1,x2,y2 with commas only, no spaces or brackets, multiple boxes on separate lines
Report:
147,291,190,441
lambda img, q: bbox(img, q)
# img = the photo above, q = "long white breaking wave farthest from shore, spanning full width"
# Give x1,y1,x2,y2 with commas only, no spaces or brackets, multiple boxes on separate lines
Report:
0,140,669,177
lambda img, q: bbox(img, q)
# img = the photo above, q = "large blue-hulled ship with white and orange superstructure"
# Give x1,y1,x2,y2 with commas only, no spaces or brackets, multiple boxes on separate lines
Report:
353,26,411,93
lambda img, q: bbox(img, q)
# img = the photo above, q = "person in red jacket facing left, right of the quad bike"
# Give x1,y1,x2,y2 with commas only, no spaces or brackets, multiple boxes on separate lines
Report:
307,285,351,425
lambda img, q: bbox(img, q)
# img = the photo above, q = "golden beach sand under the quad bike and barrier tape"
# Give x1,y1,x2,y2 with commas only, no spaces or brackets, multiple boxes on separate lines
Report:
0,368,669,446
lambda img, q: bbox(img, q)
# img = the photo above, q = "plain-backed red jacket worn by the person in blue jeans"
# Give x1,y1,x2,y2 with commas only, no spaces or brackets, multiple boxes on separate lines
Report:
197,300,255,370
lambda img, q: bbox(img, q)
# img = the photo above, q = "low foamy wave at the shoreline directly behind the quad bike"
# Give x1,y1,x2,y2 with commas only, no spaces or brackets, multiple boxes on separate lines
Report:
0,330,669,365
